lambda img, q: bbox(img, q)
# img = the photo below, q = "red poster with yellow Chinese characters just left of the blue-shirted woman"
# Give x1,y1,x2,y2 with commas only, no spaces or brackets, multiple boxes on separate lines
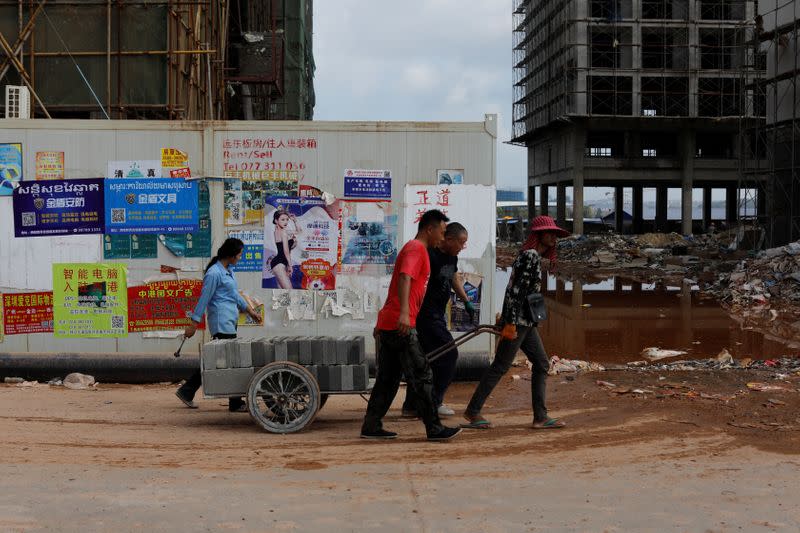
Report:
128,279,205,333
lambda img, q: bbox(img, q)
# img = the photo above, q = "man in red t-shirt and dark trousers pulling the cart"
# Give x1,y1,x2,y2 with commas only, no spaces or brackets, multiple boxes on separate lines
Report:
361,210,461,440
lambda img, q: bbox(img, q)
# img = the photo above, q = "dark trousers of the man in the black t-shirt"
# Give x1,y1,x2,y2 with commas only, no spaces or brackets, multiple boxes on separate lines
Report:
403,315,458,410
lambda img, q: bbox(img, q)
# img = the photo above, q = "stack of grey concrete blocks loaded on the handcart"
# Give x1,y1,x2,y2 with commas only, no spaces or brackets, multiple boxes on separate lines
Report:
201,337,369,396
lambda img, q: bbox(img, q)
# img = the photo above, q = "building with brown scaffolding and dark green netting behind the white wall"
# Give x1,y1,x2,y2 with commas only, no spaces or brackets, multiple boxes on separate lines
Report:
0,0,314,120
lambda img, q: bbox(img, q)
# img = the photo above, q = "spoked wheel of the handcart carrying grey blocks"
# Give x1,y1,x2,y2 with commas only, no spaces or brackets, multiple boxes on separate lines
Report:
247,361,321,433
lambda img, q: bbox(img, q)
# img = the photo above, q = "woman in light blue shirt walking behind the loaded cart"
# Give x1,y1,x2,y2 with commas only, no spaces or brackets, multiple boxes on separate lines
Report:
175,239,261,411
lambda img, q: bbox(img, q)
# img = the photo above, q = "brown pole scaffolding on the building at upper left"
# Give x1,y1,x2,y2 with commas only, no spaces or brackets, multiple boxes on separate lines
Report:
0,0,227,119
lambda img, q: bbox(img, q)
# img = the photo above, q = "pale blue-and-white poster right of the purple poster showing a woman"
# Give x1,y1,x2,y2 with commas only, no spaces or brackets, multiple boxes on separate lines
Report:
341,202,397,272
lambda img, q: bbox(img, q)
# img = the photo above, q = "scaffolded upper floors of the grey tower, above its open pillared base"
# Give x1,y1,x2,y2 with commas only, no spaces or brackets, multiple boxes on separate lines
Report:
513,0,754,144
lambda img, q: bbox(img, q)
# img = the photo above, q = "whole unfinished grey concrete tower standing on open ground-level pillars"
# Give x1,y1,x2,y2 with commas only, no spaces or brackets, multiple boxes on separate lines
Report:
512,0,757,234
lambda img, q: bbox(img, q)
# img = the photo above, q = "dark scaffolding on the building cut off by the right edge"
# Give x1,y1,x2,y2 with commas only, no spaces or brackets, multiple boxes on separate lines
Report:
740,0,800,246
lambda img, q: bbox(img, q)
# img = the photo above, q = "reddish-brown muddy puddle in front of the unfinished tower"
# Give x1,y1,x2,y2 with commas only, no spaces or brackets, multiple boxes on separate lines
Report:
495,271,800,363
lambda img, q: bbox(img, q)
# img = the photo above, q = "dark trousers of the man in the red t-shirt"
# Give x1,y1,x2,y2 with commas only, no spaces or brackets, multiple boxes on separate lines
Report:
361,329,444,436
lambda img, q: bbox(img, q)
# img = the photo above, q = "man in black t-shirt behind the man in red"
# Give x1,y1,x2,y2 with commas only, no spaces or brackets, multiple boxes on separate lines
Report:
403,222,475,416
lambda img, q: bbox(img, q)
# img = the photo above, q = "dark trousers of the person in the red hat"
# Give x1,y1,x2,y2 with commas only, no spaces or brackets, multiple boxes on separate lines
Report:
467,326,550,422
